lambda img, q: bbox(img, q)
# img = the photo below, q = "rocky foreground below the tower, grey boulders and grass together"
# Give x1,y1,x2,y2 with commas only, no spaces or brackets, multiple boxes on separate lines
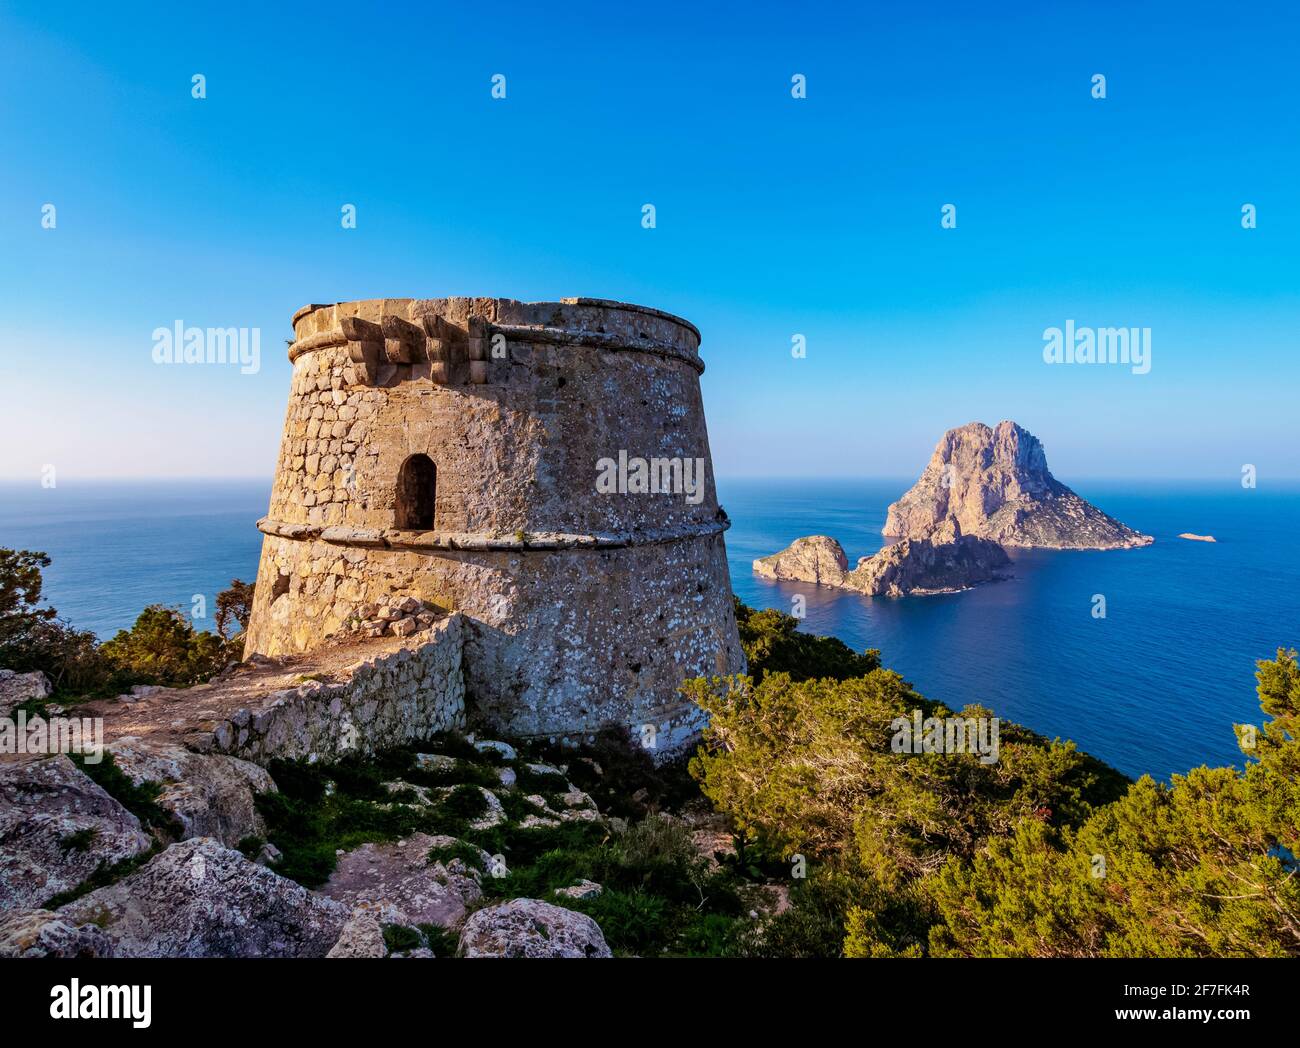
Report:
0,707,780,958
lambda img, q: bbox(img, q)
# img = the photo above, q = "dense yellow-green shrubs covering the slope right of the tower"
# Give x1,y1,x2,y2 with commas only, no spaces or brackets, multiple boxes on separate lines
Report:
685,609,1300,957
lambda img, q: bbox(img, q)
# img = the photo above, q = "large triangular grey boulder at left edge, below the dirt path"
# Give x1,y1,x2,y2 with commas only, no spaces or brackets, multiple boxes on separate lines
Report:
0,754,152,910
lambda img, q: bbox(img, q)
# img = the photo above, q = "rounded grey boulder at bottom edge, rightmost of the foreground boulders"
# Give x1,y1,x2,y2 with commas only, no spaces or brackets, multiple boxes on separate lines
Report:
460,898,612,957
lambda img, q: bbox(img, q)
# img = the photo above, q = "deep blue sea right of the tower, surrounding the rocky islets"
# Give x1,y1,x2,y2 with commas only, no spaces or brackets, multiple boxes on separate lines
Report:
719,480,1300,778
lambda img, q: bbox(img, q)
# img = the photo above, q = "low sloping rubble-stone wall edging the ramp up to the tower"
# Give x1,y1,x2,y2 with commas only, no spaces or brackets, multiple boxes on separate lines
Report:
197,615,465,763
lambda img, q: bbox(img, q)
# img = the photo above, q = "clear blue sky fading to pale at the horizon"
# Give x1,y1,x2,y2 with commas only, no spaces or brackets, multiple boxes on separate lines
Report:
0,0,1300,484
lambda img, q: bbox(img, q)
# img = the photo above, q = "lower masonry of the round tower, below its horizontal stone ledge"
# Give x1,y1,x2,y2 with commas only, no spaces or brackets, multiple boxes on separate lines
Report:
244,536,745,754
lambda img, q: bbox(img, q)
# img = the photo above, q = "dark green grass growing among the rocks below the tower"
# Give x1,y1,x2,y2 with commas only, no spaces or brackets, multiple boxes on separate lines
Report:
249,740,744,957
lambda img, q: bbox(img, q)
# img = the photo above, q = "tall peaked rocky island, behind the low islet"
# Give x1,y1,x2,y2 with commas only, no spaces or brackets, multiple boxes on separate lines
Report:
881,421,1154,550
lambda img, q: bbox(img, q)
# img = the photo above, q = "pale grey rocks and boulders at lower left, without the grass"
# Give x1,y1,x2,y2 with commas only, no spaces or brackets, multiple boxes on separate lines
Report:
0,740,610,957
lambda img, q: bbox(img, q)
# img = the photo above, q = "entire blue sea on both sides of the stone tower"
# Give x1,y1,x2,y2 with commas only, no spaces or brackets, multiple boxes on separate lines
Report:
0,478,1300,779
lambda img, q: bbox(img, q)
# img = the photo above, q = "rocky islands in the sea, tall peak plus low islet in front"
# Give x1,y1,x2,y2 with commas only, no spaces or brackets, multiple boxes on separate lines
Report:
754,421,1149,597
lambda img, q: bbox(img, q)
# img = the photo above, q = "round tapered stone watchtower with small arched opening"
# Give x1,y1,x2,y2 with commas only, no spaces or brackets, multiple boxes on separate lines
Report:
247,298,745,753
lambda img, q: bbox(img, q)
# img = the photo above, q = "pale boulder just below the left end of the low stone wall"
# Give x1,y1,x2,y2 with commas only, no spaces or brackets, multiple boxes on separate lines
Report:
108,736,276,848
